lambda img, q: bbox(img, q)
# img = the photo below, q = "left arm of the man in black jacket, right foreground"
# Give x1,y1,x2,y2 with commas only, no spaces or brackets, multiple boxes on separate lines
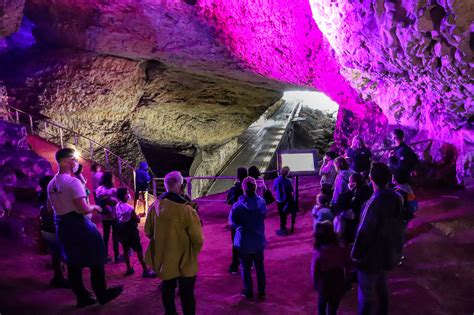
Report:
351,199,379,263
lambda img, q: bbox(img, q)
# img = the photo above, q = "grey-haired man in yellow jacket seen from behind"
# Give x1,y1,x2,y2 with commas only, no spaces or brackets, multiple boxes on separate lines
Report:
145,171,203,315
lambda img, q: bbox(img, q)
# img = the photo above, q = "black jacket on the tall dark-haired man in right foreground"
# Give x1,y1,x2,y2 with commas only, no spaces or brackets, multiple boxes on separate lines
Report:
352,189,405,272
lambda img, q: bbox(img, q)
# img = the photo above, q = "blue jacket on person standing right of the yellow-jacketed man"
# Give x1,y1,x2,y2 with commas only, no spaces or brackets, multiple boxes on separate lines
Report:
229,195,267,254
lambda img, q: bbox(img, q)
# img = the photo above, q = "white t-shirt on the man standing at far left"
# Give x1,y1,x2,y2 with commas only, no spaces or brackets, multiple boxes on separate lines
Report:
48,174,86,215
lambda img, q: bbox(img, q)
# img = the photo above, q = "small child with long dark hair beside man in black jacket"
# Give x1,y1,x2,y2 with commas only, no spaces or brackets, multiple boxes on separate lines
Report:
311,221,351,315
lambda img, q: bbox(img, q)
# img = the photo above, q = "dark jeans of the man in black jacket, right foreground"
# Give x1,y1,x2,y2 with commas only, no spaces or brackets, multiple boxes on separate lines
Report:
357,271,388,315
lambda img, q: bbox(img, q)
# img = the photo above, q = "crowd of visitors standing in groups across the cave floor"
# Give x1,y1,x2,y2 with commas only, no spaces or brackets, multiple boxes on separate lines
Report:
39,129,418,314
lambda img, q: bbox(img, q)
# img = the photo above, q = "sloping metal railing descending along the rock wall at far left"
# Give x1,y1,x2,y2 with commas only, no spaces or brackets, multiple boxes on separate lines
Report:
4,105,135,190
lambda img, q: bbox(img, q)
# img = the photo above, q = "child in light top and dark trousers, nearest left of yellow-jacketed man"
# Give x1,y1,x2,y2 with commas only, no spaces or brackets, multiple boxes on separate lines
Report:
115,187,156,278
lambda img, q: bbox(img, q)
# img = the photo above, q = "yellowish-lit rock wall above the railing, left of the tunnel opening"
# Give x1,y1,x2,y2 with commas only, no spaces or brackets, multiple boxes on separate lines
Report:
0,48,281,180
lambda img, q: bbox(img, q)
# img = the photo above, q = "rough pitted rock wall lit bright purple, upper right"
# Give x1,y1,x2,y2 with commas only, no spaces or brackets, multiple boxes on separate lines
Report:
311,0,474,178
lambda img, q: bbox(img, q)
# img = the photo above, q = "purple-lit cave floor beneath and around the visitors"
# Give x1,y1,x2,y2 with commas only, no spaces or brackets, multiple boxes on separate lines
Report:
0,178,474,315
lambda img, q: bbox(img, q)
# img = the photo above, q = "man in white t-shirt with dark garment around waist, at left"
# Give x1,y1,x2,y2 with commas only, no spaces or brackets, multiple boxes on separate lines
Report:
48,148,123,307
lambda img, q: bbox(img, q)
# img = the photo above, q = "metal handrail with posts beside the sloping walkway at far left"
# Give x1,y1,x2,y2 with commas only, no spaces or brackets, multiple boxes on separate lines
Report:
5,105,135,187
